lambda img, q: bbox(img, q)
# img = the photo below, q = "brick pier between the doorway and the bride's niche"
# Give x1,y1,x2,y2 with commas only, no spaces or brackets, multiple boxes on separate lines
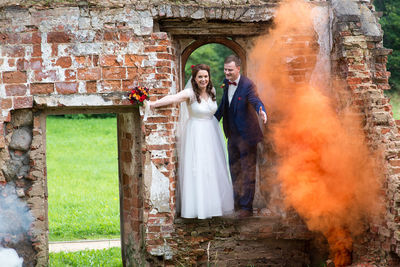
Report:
143,32,179,259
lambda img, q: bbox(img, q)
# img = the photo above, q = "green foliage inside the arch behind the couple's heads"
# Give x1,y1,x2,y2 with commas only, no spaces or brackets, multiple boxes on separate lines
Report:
185,43,235,103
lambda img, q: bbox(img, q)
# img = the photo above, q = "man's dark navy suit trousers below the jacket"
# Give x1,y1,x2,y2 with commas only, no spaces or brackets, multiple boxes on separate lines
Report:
228,134,257,211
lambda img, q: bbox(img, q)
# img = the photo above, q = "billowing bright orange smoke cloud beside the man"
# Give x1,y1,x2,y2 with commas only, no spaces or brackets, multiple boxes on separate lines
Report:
249,0,380,266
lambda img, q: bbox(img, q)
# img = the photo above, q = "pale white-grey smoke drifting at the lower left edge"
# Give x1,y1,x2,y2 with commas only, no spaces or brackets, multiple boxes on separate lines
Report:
0,184,33,267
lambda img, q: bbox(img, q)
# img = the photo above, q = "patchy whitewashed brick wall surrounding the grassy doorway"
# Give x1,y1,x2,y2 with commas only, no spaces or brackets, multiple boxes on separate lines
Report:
0,3,177,266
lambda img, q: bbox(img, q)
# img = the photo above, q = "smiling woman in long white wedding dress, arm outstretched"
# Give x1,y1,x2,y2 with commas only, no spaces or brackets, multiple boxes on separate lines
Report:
148,64,233,219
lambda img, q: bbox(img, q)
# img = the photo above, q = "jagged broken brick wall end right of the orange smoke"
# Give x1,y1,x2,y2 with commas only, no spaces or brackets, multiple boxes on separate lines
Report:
332,1,400,266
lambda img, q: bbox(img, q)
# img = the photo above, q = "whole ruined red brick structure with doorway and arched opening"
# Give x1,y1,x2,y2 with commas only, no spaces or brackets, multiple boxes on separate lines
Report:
0,0,400,266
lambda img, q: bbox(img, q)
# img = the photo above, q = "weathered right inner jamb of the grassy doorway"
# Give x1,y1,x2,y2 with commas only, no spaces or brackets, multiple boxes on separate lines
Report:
118,112,144,266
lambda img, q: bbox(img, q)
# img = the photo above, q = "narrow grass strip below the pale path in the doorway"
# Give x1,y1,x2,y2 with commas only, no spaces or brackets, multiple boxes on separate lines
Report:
49,248,122,267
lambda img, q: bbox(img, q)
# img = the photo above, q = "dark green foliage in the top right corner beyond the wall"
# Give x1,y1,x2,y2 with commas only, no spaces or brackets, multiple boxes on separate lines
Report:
374,0,400,92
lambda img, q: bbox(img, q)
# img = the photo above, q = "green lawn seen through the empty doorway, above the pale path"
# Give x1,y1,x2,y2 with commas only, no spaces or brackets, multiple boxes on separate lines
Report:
46,116,120,241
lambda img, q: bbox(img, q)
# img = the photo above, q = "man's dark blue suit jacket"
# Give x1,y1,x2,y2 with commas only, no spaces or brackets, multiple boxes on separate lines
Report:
214,75,266,144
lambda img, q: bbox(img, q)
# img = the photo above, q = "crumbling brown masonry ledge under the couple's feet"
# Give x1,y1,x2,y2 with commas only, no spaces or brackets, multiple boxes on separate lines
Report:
162,215,321,266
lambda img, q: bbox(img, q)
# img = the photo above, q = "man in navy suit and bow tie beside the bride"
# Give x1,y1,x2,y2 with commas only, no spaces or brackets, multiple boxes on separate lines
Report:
214,55,267,218
